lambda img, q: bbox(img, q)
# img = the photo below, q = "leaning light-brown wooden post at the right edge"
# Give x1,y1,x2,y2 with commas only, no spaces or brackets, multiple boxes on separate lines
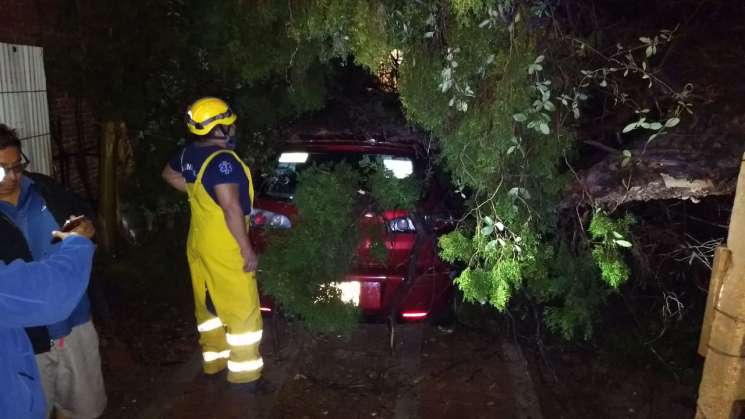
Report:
696,156,745,419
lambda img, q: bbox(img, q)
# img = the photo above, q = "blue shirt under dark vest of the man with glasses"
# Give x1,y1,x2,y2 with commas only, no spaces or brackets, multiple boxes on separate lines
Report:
0,176,91,339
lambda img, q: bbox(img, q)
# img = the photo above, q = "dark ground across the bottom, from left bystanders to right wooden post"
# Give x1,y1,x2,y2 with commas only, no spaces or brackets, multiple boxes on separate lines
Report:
91,231,700,419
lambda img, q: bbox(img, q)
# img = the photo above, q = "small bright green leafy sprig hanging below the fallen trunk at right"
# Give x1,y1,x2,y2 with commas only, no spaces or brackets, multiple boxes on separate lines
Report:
590,211,635,288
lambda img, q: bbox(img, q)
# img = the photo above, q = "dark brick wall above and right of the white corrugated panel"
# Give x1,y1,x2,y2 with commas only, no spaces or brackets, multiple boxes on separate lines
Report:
0,0,100,200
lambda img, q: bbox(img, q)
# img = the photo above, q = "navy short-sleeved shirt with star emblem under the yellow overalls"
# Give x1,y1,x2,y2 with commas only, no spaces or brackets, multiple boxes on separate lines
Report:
168,143,251,215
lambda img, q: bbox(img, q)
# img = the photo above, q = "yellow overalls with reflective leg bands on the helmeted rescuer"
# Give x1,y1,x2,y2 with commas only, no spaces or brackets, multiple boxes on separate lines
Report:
186,150,264,383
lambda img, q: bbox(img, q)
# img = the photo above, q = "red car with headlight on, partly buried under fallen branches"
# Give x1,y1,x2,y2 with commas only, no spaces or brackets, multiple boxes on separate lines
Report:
252,137,458,321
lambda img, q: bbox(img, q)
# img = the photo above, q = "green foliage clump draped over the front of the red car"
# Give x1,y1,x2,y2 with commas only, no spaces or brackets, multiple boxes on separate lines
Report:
260,165,359,333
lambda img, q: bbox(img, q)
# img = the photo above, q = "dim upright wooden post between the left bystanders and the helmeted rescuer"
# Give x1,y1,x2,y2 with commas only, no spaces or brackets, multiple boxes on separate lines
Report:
96,121,118,252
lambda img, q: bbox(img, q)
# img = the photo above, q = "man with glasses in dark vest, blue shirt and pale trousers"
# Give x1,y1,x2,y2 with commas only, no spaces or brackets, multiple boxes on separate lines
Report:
0,123,106,419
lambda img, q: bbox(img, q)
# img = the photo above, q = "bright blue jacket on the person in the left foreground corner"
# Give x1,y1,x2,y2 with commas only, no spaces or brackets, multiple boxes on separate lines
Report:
0,236,95,419
